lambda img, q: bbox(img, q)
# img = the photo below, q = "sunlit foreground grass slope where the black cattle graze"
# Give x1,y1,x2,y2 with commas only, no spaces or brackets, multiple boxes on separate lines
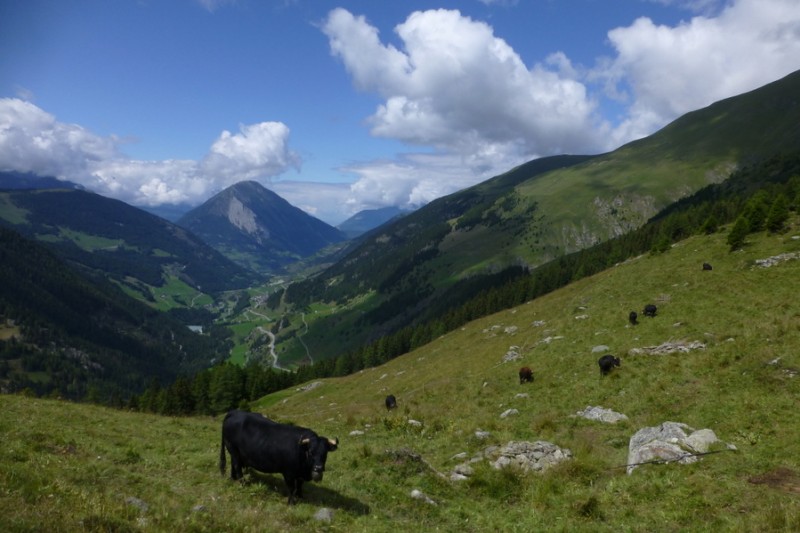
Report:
0,221,800,531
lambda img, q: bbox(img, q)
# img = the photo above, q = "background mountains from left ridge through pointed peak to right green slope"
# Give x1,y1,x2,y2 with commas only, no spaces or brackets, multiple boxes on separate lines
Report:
0,67,800,394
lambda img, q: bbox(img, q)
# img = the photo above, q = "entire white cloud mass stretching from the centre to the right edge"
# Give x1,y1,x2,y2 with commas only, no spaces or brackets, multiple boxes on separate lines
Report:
321,0,800,216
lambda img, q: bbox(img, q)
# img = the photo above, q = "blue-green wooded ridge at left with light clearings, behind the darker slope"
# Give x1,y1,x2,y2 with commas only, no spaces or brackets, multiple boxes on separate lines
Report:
0,189,259,298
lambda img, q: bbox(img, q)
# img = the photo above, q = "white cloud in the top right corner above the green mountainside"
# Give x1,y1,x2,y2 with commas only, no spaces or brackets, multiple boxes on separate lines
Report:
595,0,800,143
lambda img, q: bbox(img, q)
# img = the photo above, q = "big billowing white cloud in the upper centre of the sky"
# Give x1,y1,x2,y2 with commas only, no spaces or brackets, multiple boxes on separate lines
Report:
323,8,602,158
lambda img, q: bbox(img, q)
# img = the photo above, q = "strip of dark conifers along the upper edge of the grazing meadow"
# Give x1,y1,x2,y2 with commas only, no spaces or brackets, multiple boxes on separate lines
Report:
128,154,800,414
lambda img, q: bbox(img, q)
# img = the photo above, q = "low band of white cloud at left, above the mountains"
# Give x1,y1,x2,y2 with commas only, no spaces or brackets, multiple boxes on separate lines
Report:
0,98,300,206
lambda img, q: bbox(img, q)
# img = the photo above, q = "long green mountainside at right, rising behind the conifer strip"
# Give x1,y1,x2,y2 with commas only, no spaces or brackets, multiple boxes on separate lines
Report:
274,71,800,357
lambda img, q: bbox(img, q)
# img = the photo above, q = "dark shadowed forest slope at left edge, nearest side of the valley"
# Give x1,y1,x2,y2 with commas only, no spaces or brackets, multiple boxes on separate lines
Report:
0,227,229,405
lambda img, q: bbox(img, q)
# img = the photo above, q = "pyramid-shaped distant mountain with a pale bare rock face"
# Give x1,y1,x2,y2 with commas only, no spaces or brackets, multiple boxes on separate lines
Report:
177,181,347,273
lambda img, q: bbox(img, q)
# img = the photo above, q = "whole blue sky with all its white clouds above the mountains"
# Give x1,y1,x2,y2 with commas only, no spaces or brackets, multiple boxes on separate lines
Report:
0,0,800,224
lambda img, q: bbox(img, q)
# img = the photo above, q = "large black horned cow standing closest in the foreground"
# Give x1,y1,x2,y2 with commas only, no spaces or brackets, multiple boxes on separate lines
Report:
219,411,339,505
